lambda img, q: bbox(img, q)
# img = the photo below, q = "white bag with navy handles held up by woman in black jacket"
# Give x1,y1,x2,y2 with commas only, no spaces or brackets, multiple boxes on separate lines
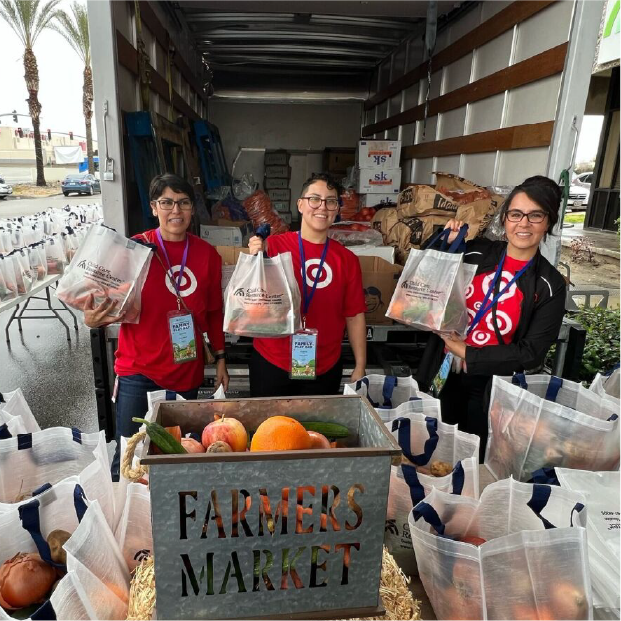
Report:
386,225,476,335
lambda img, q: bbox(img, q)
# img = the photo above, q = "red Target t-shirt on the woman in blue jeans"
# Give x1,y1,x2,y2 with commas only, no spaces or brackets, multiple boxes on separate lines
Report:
114,229,224,392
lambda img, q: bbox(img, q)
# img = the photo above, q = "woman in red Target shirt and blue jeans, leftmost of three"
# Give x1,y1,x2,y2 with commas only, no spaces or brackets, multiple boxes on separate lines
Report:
84,174,229,480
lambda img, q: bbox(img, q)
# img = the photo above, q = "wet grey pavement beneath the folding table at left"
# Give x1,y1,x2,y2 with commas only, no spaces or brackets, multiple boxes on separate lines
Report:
0,296,98,432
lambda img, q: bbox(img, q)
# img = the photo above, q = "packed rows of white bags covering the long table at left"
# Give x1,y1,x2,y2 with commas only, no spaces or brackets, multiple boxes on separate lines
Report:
0,205,103,302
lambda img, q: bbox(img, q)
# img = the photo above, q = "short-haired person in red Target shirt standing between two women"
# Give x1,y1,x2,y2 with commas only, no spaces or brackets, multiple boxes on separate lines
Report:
249,174,367,397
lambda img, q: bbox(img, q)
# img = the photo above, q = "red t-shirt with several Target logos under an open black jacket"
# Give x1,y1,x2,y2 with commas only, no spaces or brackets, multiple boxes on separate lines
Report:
466,256,528,347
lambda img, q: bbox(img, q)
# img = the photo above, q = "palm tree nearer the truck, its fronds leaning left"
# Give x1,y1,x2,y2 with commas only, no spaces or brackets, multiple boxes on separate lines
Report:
50,2,95,175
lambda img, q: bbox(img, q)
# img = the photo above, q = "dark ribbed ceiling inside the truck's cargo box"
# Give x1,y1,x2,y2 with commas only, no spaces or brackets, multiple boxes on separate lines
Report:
162,0,462,99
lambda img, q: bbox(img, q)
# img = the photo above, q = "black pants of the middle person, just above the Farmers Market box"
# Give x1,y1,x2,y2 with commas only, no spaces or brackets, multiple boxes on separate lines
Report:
248,349,343,397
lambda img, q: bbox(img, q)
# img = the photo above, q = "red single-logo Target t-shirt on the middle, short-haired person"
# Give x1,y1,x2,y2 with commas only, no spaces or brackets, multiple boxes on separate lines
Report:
254,233,366,375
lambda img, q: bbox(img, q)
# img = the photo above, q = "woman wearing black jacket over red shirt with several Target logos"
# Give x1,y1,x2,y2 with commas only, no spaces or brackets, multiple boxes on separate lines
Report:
417,176,566,458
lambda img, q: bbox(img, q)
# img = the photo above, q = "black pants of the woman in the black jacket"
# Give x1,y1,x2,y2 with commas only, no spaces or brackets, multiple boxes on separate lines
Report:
440,372,491,463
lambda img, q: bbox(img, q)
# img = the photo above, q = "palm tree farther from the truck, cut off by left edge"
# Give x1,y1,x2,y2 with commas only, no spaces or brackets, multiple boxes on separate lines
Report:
0,0,60,185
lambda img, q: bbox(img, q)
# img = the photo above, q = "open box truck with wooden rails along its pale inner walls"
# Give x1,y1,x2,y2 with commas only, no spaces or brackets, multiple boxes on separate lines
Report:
88,0,604,436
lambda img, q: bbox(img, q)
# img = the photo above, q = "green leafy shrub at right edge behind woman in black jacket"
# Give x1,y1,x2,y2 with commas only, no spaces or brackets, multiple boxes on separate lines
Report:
572,308,621,382
